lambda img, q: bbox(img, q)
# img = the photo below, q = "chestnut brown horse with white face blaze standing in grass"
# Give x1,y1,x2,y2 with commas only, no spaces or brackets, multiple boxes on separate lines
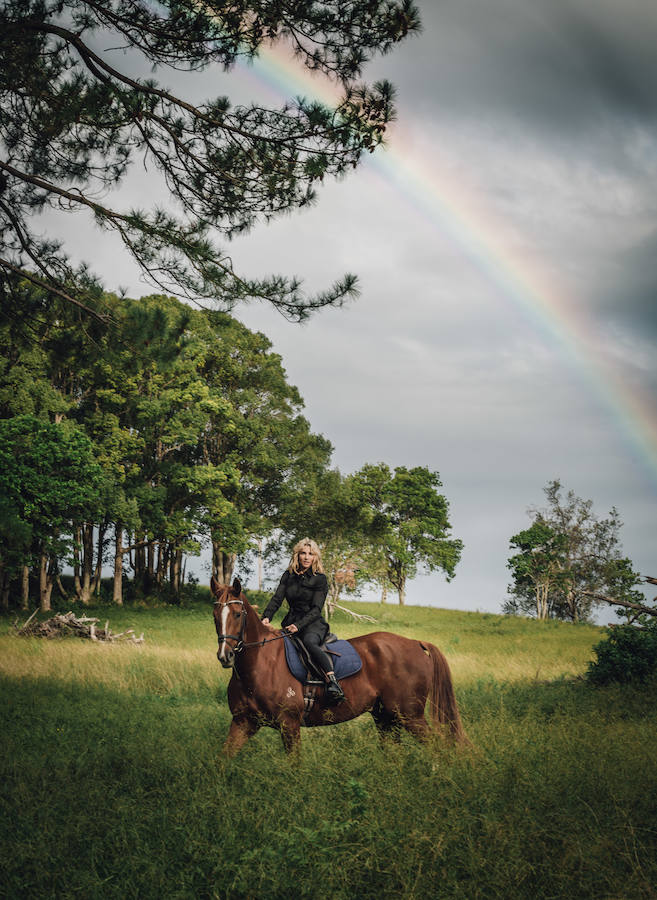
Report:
211,578,467,756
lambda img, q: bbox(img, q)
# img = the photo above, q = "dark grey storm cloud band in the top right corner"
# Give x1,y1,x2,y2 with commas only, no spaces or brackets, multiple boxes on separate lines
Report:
368,0,657,135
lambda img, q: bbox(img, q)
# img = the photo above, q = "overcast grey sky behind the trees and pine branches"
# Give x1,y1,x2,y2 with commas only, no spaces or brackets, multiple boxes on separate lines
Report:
52,0,657,611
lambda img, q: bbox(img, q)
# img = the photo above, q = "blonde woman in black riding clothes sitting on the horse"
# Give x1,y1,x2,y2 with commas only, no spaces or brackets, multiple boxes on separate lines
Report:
262,538,344,703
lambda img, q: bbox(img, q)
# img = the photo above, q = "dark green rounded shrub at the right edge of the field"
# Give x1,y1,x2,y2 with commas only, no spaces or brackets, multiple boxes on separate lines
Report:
587,620,657,684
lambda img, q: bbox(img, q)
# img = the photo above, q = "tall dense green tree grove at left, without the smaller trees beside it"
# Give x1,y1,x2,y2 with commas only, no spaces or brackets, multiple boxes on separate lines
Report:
0,283,331,602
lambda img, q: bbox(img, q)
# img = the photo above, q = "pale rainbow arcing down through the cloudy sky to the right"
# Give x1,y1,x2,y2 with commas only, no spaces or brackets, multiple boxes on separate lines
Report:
237,45,657,489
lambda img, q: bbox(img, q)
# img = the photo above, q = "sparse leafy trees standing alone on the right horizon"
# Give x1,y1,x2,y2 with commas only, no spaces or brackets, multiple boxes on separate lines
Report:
505,481,643,622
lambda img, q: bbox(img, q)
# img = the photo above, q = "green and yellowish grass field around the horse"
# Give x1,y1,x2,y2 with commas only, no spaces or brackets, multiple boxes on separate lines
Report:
0,604,657,900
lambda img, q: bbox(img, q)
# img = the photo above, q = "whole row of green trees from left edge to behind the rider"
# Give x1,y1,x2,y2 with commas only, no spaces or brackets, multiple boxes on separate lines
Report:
0,281,461,609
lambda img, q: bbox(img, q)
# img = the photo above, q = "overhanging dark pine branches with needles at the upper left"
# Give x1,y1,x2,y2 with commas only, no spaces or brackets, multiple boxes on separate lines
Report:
0,0,419,319
